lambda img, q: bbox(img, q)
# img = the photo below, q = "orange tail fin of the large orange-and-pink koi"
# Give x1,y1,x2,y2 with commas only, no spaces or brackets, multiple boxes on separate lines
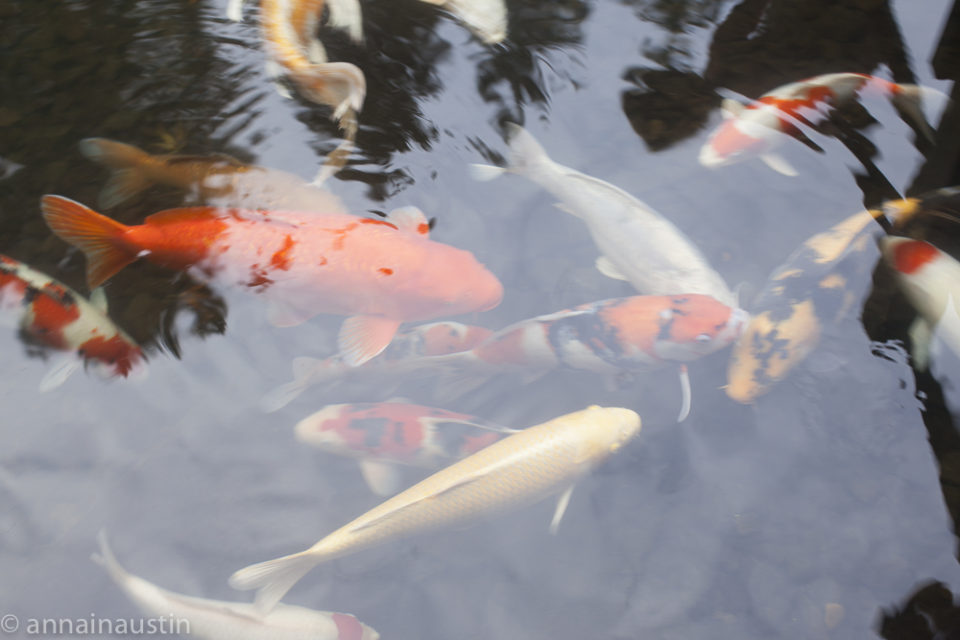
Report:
40,195,137,290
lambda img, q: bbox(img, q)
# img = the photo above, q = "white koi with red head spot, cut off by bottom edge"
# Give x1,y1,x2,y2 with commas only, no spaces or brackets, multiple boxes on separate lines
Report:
93,531,380,640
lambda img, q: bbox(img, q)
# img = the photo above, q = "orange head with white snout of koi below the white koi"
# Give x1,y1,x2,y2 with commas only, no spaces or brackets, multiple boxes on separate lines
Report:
653,294,750,362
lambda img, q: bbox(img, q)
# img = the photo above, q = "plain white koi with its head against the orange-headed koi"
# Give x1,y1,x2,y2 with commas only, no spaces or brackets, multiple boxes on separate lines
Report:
474,124,736,306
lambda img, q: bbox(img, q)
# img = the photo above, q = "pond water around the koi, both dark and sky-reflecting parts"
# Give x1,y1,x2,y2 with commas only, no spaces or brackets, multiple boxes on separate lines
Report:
0,0,960,640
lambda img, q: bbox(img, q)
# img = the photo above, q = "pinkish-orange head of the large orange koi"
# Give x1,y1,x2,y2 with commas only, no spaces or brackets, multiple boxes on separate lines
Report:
394,242,503,320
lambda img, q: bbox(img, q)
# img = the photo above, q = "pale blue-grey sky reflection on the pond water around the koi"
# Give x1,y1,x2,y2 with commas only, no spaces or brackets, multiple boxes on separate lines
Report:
0,0,960,638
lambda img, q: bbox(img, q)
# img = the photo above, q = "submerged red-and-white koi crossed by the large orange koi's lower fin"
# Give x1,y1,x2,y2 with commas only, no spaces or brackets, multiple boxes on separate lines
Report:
260,321,493,413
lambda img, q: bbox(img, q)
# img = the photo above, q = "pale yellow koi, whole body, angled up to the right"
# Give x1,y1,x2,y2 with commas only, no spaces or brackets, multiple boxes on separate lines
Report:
230,406,640,611
